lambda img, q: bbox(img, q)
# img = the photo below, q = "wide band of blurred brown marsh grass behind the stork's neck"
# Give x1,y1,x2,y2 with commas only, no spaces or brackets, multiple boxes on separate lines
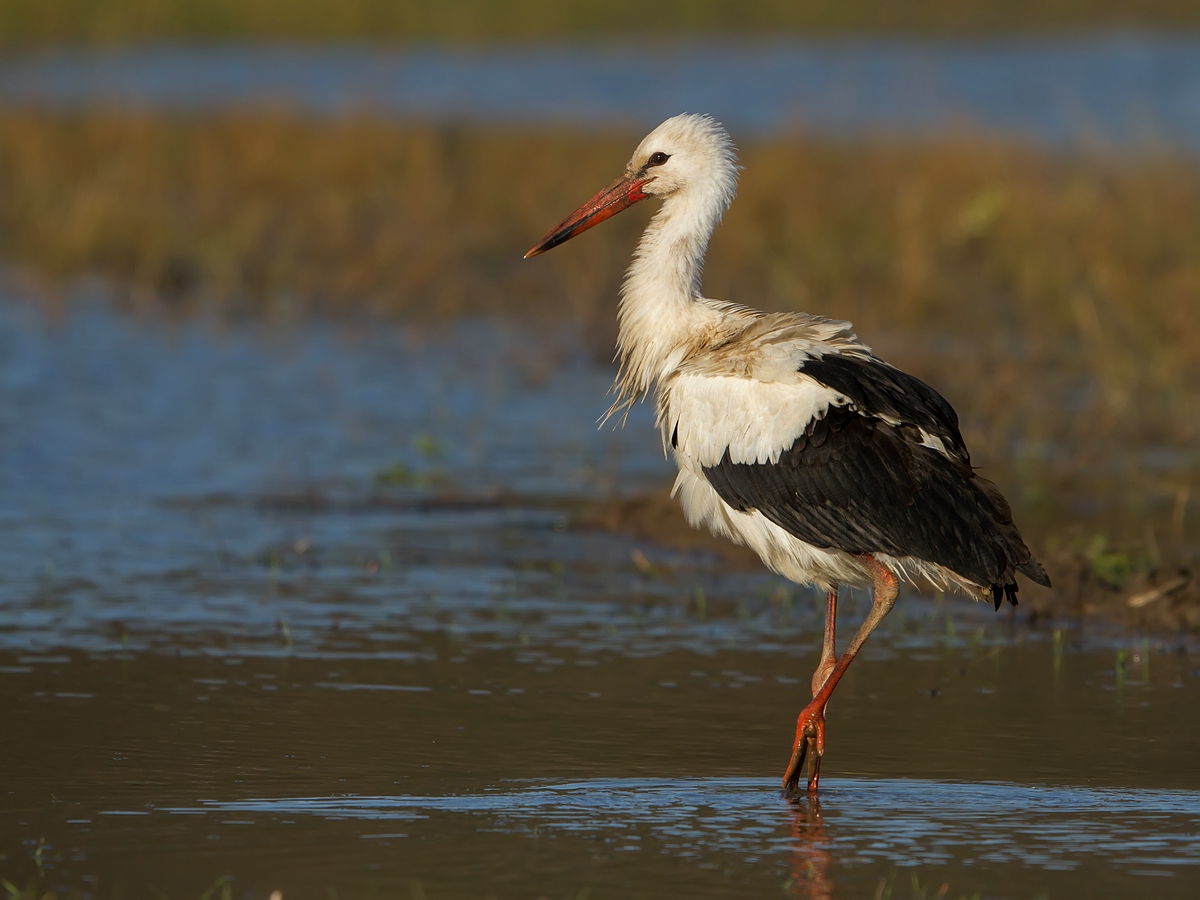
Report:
0,112,1200,568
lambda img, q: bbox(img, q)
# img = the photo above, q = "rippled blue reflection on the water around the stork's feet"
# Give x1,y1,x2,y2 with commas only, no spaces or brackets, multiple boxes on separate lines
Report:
175,778,1200,874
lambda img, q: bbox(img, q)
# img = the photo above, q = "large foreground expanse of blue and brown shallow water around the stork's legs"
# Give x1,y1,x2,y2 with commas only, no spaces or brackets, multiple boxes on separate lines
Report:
0,304,1200,900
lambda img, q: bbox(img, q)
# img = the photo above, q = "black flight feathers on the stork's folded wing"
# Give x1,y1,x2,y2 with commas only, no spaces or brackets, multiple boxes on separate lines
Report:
704,354,1050,608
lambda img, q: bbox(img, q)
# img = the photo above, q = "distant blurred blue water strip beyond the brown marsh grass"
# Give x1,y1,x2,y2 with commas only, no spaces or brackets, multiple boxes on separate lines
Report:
7,32,1200,151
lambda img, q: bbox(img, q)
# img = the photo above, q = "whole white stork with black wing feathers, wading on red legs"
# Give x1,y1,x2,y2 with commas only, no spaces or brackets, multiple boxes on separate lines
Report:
526,115,1050,793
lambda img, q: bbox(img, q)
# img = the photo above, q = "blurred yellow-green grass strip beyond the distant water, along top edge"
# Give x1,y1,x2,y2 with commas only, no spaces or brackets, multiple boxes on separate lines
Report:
7,0,1200,46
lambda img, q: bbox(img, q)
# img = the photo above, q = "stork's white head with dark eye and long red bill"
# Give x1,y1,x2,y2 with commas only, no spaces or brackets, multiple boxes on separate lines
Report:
526,113,738,259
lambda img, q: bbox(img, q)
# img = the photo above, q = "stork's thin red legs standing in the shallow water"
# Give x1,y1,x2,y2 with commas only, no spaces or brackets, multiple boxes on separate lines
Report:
784,553,900,793
